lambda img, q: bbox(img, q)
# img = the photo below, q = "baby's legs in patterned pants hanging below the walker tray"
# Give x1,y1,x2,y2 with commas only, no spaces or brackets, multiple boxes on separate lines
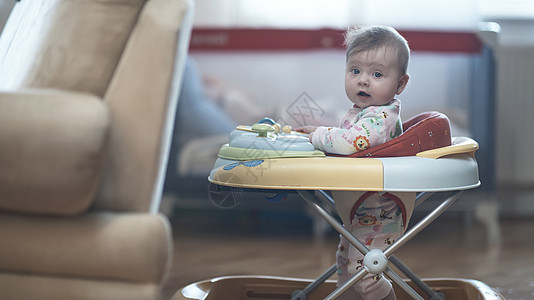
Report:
334,192,415,299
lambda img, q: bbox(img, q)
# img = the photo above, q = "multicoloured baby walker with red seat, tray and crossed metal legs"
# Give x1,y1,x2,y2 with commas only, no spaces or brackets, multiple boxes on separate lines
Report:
173,112,504,300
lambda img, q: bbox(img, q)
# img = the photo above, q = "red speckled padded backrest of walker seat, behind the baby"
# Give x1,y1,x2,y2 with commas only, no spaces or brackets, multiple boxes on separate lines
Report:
327,111,452,157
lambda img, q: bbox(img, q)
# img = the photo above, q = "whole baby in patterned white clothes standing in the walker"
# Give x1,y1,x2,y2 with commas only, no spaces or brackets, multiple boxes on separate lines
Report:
297,26,415,299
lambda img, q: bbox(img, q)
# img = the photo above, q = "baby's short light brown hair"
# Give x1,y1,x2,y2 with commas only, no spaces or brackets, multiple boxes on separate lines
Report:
345,25,410,74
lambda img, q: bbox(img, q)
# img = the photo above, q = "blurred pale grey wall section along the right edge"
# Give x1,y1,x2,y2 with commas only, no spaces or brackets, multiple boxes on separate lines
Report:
496,19,534,216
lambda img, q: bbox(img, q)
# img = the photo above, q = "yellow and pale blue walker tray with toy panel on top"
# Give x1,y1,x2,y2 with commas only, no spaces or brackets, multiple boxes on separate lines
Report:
208,116,480,192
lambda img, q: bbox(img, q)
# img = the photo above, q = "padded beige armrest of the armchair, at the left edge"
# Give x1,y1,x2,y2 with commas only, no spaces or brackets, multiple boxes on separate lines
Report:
0,90,109,215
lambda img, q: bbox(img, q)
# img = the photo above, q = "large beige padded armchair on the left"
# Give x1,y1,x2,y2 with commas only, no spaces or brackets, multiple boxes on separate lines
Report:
0,0,192,299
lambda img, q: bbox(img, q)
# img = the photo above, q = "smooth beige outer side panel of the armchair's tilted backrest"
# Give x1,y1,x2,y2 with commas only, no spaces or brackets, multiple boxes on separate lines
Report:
96,0,192,212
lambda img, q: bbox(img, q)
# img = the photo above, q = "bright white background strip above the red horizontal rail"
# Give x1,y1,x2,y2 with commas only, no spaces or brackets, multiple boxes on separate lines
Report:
194,0,485,29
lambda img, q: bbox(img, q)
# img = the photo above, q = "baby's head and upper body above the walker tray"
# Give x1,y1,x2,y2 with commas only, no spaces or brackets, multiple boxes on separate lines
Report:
299,26,410,155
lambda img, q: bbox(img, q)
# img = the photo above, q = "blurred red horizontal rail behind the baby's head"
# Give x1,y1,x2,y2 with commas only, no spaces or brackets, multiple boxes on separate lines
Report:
190,28,482,53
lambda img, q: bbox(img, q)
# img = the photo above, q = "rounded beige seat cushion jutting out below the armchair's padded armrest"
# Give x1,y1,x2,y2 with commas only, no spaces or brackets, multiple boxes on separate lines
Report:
0,212,172,284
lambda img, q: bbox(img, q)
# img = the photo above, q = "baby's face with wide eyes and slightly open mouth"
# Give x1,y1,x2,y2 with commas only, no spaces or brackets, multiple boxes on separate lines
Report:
345,47,409,108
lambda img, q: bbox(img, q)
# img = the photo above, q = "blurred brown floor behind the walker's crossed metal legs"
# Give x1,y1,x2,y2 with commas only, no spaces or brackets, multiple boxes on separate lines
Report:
166,192,534,299
